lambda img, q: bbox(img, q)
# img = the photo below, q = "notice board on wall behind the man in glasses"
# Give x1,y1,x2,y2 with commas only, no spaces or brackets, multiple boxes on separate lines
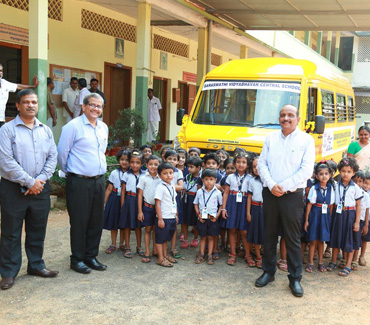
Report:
49,64,102,107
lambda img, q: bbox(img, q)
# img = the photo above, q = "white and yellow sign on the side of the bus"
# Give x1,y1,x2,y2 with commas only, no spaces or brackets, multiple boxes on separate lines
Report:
322,126,355,157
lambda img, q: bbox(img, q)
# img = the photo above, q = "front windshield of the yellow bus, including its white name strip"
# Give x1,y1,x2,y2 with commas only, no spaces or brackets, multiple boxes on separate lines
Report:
192,80,301,128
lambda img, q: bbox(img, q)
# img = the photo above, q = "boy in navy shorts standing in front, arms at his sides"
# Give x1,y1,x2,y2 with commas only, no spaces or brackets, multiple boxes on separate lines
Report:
154,162,178,267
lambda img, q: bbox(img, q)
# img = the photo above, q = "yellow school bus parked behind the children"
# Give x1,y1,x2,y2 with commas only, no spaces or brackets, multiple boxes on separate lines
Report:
174,58,356,162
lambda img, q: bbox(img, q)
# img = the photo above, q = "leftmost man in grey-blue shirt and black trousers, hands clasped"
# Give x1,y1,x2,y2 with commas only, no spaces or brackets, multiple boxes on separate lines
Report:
0,89,58,290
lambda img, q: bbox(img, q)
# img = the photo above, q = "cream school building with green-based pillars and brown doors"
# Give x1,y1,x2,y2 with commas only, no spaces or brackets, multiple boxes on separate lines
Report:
0,0,370,141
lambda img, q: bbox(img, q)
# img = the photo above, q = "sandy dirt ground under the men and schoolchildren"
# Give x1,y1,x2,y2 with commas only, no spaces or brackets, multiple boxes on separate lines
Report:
0,205,370,324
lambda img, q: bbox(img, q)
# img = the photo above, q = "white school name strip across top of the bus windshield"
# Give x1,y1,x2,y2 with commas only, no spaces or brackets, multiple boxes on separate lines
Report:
202,81,301,94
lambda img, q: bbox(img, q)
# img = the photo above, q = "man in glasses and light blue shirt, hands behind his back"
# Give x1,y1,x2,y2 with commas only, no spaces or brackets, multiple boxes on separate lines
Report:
58,93,108,274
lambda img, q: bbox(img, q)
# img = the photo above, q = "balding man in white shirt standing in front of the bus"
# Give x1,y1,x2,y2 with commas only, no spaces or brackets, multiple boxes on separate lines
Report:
255,105,315,297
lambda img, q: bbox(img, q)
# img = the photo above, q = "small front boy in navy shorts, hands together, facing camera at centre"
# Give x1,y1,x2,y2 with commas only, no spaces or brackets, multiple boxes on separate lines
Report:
194,168,222,265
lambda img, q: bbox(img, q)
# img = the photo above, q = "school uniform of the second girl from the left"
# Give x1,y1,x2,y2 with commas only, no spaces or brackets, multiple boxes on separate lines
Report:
118,169,143,230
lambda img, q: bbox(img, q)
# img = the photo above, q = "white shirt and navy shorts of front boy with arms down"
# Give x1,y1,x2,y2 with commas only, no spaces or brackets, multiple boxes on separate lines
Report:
154,181,177,244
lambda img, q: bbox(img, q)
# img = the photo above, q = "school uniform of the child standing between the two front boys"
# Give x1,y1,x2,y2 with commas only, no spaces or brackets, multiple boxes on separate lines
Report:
182,174,200,226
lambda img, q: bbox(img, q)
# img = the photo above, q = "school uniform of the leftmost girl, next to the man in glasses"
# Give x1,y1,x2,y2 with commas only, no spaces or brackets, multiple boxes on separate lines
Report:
103,167,124,230
